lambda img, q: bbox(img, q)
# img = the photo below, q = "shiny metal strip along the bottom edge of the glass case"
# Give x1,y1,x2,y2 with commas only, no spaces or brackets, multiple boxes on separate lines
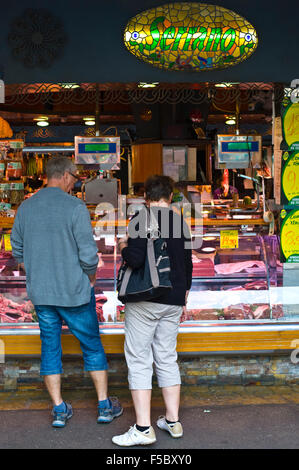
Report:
0,321,299,337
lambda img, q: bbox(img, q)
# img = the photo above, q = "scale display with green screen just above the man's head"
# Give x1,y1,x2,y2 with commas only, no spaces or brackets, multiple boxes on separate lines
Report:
75,136,120,170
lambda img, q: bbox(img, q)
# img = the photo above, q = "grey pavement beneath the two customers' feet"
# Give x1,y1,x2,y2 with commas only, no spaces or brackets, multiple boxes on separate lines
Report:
0,385,299,454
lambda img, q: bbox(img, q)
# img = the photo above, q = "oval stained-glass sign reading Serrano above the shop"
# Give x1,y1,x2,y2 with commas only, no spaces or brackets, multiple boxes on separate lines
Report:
124,2,258,72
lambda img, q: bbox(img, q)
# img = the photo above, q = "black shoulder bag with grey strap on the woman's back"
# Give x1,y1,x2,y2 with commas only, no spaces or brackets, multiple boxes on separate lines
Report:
117,210,172,303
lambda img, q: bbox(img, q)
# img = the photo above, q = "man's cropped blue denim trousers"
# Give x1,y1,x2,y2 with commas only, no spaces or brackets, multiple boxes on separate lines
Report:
35,289,108,375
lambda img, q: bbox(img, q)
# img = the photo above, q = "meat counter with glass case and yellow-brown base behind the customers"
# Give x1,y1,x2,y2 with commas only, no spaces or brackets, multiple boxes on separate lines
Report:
0,204,299,355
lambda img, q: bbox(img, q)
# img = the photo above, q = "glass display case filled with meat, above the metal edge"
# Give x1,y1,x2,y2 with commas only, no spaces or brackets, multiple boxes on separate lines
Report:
0,221,299,326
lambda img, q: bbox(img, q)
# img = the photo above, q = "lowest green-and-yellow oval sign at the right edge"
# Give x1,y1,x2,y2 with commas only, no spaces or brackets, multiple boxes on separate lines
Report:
280,207,299,263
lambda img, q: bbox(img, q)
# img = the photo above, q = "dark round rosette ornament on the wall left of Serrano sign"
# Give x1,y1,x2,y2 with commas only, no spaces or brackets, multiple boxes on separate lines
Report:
8,9,67,68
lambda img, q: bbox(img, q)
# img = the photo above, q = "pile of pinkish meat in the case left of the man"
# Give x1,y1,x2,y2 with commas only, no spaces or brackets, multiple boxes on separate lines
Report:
0,294,36,323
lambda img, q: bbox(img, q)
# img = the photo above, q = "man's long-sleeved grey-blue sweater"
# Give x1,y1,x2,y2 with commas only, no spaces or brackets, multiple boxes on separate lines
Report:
11,187,98,307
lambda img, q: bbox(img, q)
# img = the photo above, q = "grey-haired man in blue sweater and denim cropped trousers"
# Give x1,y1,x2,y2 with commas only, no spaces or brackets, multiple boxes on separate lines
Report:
11,157,123,427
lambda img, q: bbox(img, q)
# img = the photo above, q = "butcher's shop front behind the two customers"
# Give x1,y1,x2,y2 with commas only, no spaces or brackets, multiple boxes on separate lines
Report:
0,2,299,389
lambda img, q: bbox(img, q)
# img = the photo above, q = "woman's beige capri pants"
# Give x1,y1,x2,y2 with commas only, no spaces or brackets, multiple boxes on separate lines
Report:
125,302,183,390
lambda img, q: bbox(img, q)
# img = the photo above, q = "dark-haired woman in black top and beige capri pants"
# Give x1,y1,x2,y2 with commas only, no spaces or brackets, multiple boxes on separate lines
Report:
112,175,192,447
